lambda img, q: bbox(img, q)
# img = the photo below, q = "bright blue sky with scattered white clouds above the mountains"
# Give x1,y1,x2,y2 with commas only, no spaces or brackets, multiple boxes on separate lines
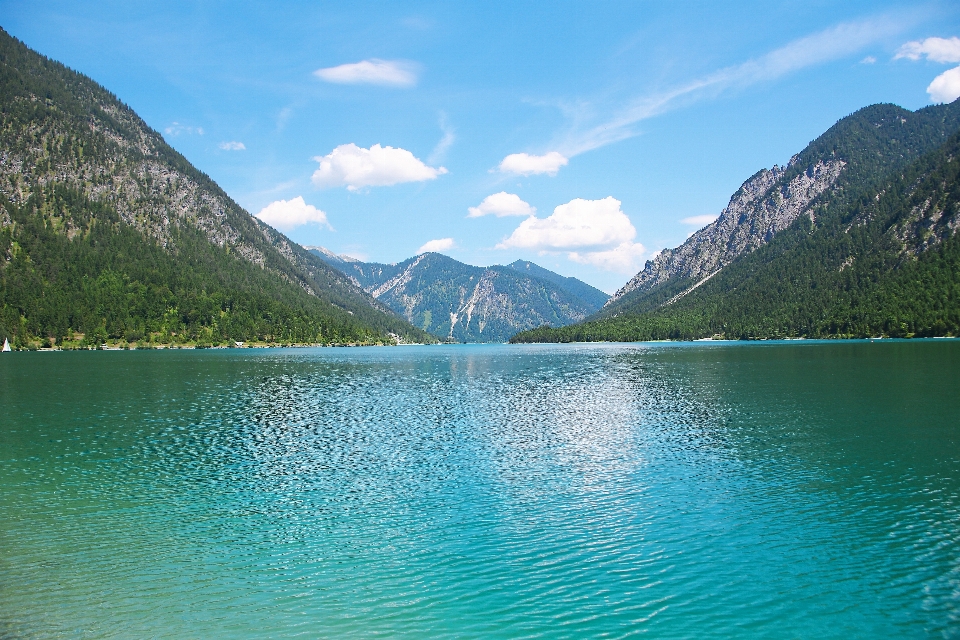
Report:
0,0,960,292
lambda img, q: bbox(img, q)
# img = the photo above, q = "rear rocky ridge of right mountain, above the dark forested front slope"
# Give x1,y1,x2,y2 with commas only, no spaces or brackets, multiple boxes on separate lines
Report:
602,105,958,315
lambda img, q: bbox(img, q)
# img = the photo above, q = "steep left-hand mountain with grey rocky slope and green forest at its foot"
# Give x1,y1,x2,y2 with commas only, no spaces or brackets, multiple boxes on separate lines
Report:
0,30,433,346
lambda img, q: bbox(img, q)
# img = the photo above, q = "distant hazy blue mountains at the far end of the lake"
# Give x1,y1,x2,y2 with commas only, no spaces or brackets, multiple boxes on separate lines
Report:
310,247,607,342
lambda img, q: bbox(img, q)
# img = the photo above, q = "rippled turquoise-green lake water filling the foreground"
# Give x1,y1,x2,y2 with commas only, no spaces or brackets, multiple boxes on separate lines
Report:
0,340,960,638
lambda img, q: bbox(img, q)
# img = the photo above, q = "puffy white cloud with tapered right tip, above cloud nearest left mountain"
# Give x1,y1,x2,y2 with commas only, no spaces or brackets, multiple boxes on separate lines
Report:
312,142,447,191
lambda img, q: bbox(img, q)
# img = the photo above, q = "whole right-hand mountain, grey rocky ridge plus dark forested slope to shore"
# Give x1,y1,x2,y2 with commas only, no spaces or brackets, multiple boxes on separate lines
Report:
515,102,960,341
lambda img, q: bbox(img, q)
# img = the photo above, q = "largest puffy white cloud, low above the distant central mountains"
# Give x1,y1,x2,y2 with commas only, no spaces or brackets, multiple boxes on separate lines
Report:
497,196,637,251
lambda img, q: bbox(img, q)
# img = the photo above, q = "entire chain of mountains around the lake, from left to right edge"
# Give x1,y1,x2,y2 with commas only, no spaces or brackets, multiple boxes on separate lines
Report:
0,30,960,349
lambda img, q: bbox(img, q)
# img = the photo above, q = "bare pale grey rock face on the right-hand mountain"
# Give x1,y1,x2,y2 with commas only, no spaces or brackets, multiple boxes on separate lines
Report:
605,156,844,307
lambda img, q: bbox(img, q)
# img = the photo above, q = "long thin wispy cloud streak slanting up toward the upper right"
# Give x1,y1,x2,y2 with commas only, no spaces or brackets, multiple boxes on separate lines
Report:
554,16,909,158
